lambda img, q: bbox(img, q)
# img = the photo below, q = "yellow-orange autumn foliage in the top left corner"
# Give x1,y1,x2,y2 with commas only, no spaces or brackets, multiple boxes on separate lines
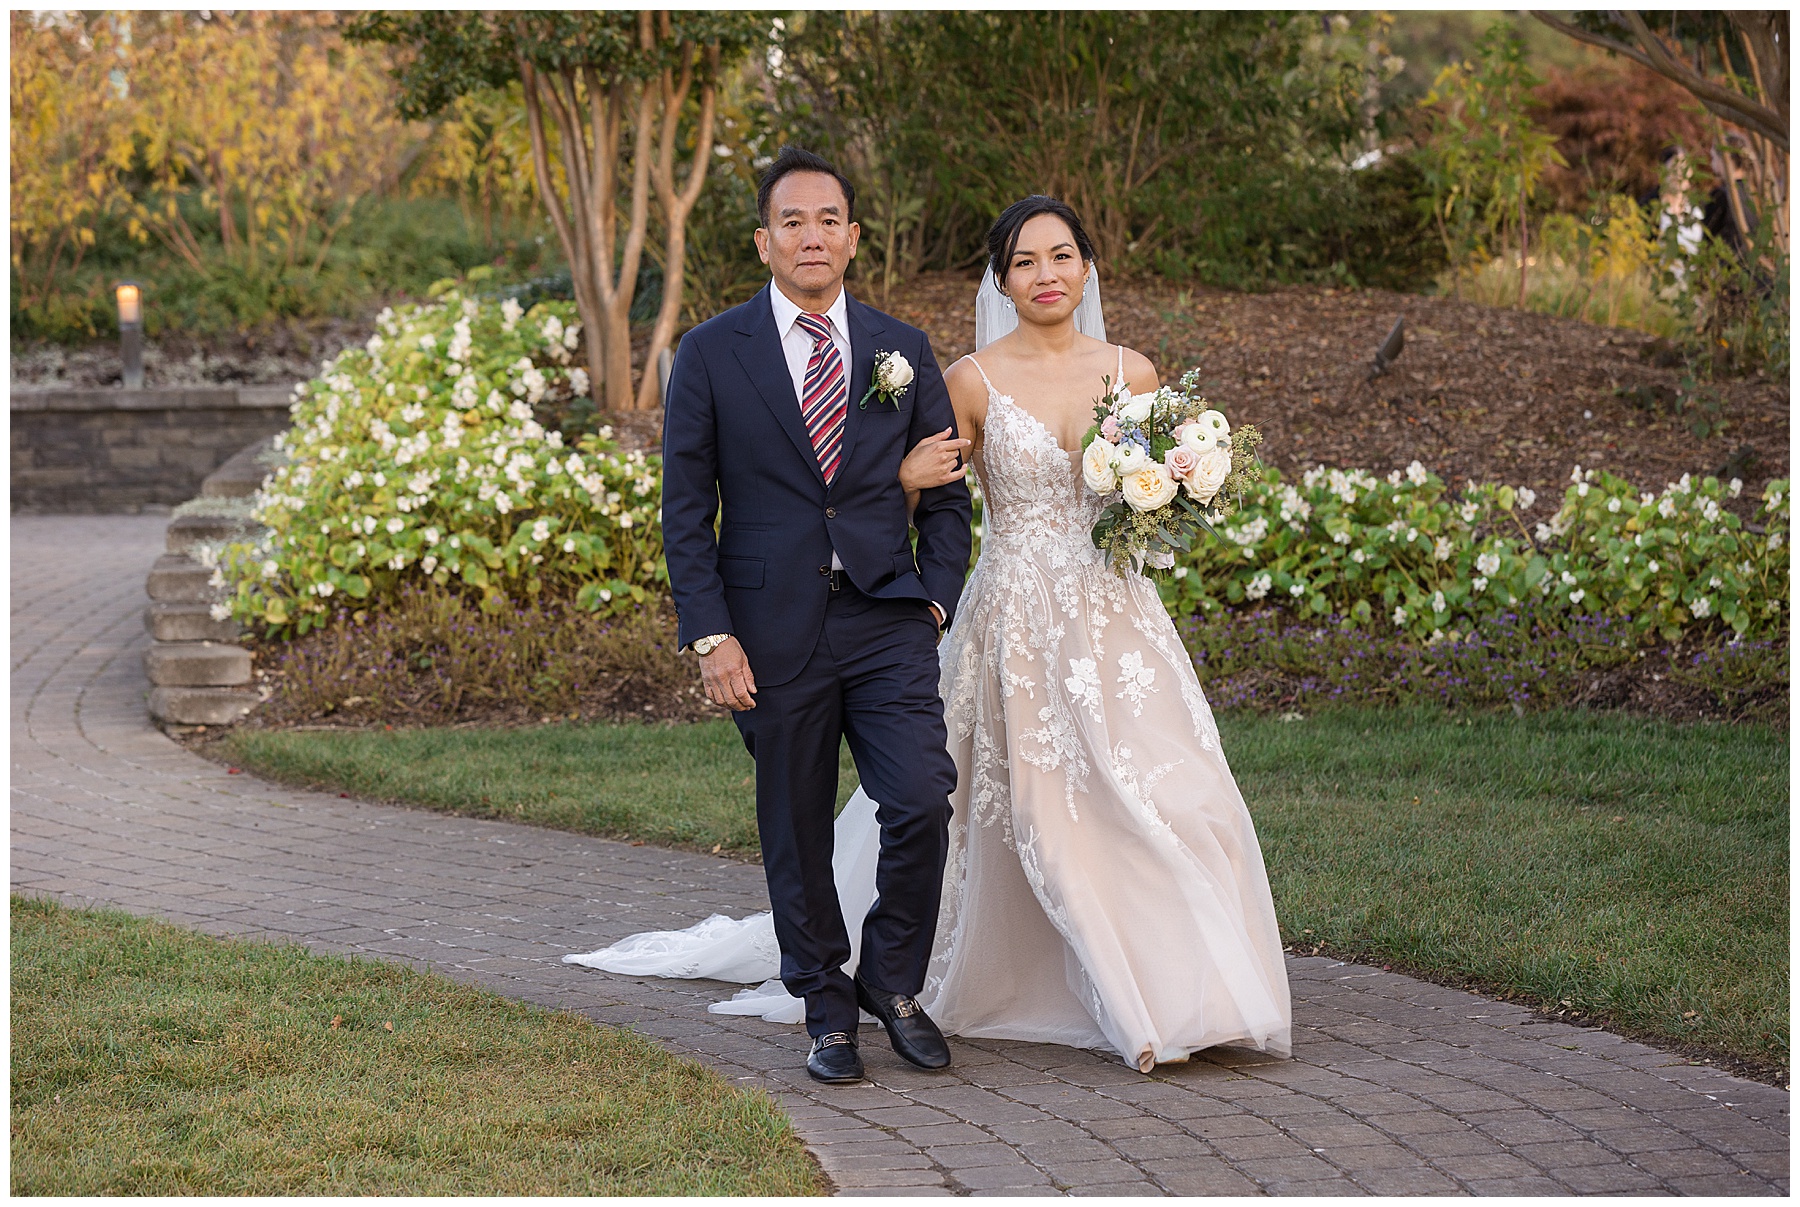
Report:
11,11,428,338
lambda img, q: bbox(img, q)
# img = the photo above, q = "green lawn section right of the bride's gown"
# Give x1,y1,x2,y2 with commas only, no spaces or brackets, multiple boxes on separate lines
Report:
1222,711,1789,1070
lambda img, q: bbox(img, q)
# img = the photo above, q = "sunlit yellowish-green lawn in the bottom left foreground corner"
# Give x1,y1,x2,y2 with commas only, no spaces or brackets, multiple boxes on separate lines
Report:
11,896,821,1196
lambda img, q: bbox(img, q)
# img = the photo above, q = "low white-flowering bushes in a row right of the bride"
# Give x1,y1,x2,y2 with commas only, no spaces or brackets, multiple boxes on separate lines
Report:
1163,460,1789,640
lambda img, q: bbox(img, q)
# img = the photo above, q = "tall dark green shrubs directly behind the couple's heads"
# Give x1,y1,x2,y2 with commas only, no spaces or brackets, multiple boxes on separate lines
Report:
772,11,1438,288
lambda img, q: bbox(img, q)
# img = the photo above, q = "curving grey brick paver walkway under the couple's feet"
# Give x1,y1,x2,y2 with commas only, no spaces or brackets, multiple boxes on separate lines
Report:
13,516,1787,1194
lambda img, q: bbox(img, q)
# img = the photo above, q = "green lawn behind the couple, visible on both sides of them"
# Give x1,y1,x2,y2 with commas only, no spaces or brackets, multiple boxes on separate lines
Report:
220,709,1787,1070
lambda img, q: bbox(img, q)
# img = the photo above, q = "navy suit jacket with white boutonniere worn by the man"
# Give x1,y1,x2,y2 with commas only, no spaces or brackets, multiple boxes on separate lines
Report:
662,284,972,687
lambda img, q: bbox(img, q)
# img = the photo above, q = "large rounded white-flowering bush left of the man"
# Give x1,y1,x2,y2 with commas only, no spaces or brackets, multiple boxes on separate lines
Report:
220,290,668,633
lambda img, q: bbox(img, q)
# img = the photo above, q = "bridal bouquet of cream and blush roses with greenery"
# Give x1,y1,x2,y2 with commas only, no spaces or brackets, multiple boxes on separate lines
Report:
1082,371,1262,570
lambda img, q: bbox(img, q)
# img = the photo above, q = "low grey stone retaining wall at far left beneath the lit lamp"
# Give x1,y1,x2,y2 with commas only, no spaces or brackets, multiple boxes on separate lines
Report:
13,385,293,513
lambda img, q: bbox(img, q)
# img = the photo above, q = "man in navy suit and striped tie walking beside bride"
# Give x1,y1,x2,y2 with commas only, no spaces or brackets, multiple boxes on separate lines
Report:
662,148,970,1083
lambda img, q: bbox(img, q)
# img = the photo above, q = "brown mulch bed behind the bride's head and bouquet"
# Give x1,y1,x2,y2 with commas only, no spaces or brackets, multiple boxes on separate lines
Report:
874,273,1787,514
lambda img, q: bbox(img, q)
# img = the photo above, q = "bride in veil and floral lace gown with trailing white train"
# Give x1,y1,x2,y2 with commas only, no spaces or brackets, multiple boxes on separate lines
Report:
563,198,1292,1072
